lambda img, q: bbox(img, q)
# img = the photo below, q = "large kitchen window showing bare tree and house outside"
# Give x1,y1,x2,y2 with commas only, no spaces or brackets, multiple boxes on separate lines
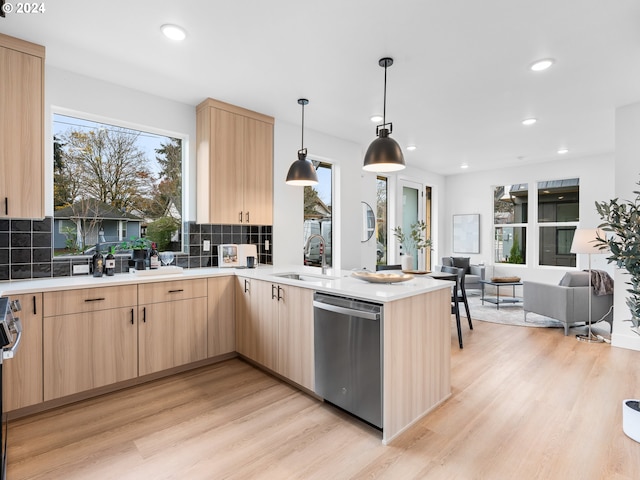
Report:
53,114,183,255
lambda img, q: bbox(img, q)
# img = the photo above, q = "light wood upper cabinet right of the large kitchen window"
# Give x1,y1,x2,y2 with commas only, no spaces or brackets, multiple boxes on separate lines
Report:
196,98,274,225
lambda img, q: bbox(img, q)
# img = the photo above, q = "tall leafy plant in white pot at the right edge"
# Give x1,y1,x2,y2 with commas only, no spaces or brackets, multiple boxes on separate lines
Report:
596,177,640,442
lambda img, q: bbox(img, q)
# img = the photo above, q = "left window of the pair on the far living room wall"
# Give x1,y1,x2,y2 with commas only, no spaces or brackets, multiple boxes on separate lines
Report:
493,183,529,264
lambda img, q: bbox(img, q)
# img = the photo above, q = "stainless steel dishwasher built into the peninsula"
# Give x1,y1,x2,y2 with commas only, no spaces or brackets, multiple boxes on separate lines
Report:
313,293,383,428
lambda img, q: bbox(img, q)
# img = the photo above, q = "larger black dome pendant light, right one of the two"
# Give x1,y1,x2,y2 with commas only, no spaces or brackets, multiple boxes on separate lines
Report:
362,57,405,172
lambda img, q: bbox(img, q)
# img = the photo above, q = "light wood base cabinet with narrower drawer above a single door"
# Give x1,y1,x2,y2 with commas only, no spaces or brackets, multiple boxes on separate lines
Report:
138,279,207,375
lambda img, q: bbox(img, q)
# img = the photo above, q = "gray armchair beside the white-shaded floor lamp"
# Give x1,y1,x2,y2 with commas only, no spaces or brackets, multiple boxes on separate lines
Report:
522,272,613,335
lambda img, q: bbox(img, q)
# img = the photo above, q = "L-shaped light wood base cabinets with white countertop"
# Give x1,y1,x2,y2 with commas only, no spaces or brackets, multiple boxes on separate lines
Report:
0,266,451,443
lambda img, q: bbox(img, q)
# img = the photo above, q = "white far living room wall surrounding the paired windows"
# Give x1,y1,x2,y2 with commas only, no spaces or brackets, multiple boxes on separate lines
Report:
442,155,614,283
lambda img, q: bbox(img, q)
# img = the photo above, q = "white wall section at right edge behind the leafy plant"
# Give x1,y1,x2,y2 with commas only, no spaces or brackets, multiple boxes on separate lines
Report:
605,103,640,350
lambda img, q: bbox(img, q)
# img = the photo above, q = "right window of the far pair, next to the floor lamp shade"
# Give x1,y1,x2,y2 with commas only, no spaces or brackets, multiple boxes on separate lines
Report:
538,178,580,267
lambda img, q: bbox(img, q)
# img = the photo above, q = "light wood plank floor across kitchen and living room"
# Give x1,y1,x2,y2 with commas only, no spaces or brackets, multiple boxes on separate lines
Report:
8,321,640,480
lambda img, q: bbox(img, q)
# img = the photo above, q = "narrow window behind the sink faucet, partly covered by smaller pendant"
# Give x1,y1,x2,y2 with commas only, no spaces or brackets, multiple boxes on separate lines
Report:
303,161,333,266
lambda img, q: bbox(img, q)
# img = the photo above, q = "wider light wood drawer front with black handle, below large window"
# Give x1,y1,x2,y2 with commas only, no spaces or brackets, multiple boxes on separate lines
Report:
43,285,138,317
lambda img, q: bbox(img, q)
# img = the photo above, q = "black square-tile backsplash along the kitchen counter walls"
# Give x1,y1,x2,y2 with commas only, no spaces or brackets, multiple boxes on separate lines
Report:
0,217,273,281
